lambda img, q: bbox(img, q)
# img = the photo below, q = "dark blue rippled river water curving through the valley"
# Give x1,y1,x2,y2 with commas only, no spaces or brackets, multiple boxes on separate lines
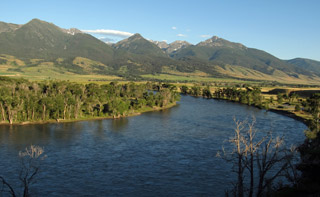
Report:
0,96,306,196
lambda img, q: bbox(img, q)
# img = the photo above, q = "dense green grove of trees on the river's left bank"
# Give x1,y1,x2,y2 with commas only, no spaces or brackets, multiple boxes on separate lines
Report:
0,78,180,124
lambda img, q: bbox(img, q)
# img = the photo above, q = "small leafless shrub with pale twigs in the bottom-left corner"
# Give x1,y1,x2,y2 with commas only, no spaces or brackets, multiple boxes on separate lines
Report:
0,145,47,197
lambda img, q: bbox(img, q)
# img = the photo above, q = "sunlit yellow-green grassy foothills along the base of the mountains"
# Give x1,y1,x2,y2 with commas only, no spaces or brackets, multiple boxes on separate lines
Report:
0,54,320,88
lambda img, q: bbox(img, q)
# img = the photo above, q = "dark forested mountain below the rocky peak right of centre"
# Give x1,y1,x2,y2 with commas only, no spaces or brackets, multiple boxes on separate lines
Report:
172,36,312,75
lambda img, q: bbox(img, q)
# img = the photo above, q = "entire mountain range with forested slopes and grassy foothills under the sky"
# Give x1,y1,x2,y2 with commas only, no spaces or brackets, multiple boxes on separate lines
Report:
0,19,320,81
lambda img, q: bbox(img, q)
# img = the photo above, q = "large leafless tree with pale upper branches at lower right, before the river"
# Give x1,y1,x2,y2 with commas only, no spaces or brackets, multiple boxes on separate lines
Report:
217,119,294,197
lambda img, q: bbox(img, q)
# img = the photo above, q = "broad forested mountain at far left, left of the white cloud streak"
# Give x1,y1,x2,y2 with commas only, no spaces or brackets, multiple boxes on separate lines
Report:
0,19,113,63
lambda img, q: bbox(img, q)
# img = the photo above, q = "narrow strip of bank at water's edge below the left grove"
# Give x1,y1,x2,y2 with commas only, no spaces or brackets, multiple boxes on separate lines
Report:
0,102,177,125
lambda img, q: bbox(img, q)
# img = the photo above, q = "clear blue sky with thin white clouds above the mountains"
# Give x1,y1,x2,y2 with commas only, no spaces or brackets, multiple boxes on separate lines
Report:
0,0,320,61
